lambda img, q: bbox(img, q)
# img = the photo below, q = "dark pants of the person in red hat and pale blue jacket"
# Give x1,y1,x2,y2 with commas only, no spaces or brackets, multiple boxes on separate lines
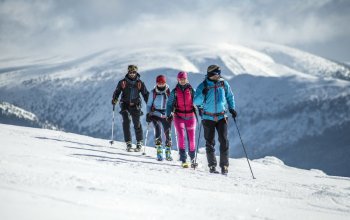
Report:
151,116,171,146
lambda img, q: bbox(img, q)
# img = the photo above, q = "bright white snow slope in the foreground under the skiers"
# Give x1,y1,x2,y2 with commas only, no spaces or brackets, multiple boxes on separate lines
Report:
0,124,350,220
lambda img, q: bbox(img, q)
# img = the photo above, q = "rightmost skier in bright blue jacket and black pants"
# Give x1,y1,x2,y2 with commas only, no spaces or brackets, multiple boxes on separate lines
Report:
194,65,237,174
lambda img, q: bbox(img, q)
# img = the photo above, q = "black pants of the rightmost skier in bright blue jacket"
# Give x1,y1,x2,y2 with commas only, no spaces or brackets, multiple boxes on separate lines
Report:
202,119,229,167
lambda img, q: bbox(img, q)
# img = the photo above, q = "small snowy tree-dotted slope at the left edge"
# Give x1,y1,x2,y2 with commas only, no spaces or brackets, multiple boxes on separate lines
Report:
0,102,57,130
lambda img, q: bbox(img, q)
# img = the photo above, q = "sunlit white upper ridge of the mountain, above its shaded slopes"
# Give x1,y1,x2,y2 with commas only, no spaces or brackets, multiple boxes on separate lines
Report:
0,43,350,86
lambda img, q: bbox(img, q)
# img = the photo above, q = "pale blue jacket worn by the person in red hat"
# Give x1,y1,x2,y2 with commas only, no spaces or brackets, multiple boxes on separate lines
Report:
147,85,169,118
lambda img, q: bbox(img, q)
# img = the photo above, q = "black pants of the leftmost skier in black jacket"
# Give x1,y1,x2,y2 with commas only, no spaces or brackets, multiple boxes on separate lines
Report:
120,103,143,142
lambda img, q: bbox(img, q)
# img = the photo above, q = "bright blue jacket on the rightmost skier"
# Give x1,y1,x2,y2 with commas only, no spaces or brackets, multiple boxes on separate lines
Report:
194,78,235,121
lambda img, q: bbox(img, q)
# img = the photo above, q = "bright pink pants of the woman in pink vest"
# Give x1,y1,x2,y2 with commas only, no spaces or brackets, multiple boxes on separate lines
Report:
174,116,196,152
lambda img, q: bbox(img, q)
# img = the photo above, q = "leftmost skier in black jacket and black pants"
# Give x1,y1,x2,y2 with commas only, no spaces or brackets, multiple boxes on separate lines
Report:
112,65,149,152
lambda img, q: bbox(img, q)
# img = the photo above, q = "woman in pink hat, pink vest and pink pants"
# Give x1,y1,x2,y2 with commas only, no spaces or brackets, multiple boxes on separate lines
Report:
166,72,196,168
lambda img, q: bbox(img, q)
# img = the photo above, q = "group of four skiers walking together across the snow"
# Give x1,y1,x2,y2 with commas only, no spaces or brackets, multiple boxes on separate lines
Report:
112,65,237,174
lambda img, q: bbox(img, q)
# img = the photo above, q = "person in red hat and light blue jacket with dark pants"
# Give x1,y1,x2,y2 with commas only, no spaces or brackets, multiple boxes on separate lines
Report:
146,75,173,161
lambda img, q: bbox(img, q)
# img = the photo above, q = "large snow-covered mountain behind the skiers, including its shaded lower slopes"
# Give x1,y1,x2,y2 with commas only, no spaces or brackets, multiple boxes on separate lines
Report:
0,43,350,176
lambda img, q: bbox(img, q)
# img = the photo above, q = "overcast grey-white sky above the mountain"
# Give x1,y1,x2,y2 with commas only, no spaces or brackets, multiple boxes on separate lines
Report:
0,0,350,61
